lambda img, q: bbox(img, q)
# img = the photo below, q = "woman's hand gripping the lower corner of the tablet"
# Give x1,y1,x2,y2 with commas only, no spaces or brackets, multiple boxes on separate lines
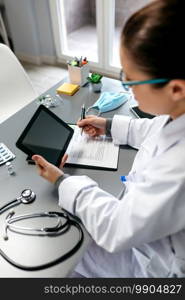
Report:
32,154,68,183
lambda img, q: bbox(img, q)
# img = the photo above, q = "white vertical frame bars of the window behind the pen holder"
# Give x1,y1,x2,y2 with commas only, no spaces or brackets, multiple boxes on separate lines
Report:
49,0,120,79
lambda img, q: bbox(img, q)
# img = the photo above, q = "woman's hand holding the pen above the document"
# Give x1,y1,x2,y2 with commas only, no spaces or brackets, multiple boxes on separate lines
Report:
77,115,106,136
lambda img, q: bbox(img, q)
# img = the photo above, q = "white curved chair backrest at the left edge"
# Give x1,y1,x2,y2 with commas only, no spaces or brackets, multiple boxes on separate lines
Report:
0,44,38,123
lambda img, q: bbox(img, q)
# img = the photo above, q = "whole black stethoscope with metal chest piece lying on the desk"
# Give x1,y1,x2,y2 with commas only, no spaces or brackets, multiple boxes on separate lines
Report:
0,189,84,271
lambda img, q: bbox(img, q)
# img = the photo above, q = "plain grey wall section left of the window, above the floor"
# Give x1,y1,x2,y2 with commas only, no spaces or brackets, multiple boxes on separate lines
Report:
4,0,56,63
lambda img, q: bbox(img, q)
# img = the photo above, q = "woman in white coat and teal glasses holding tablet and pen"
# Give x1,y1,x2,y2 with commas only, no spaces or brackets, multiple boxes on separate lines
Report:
33,0,185,277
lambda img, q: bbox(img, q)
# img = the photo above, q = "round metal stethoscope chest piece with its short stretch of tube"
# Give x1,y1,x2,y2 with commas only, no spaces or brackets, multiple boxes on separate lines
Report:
0,189,36,215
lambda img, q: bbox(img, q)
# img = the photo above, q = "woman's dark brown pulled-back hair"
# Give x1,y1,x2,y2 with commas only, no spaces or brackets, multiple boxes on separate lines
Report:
121,0,185,87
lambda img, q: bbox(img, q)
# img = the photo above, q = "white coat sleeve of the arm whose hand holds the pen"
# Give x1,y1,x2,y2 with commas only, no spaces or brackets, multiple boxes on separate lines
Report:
111,115,168,149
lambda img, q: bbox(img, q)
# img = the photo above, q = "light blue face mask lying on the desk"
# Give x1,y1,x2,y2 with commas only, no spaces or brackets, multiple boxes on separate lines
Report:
87,92,131,115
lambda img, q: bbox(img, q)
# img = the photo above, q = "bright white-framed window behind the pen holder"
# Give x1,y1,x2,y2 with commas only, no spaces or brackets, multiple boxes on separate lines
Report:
50,0,151,77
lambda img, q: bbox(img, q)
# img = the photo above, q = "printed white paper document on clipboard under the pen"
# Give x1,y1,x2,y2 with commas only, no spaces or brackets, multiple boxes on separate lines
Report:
66,125,119,170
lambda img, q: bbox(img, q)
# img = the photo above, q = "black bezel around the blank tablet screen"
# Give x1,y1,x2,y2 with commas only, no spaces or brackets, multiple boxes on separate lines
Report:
16,104,74,167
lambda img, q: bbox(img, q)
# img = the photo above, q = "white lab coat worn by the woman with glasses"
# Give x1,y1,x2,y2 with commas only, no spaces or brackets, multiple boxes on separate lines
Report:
59,114,185,277
